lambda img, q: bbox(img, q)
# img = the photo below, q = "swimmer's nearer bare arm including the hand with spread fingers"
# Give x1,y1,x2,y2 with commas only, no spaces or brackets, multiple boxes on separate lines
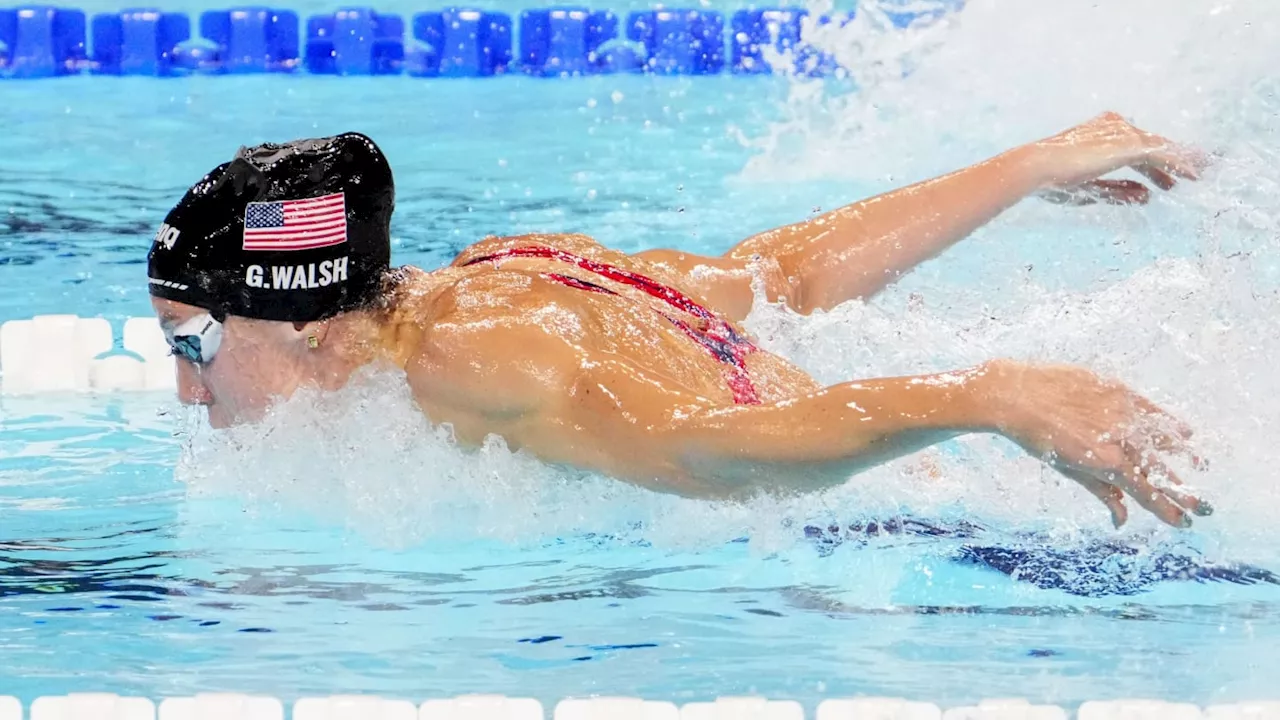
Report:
555,360,1212,527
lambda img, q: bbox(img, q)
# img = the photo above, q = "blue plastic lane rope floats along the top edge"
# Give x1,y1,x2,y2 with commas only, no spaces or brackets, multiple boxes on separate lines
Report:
0,5,952,78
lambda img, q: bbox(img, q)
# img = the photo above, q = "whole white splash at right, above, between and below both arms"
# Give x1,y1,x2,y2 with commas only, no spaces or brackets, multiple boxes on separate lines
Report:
737,0,1280,559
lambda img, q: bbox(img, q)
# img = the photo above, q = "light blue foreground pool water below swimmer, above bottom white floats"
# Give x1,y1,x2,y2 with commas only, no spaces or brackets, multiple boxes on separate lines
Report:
0,386,1280,706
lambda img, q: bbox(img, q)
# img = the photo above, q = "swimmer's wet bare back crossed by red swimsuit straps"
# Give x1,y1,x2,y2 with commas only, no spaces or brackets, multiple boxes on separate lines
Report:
386,236,817,445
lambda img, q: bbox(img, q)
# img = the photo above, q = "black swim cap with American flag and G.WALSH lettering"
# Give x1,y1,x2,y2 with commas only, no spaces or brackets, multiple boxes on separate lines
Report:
147,133,396,323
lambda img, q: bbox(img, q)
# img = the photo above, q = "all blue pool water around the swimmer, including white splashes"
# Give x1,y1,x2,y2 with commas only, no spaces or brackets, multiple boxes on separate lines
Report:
0,0,1280,707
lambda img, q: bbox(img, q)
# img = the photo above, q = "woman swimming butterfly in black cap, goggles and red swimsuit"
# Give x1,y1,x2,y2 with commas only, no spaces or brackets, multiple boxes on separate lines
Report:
148,113,1212,528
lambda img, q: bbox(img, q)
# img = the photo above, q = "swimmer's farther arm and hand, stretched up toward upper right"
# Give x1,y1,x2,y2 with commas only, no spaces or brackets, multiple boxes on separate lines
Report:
730,113,1199,302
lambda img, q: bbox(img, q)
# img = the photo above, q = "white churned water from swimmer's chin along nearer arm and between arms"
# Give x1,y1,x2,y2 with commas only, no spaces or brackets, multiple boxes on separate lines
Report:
180,254,1280,560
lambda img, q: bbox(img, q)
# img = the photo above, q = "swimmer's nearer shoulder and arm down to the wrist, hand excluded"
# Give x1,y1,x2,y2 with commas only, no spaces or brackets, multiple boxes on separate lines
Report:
406,302,996,474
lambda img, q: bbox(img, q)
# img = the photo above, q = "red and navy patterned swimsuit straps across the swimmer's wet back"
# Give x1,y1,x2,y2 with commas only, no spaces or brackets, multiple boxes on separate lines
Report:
466,245,760,405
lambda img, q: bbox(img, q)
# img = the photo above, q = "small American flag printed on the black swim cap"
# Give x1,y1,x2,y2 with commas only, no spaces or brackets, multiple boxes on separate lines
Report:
244,192,347,250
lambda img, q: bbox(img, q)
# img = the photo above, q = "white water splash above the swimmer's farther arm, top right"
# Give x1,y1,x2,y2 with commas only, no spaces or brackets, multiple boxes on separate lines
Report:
745,0,1280,184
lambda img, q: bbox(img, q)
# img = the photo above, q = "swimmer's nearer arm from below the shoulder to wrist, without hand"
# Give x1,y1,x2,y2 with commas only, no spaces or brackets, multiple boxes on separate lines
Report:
557,363,997,497
